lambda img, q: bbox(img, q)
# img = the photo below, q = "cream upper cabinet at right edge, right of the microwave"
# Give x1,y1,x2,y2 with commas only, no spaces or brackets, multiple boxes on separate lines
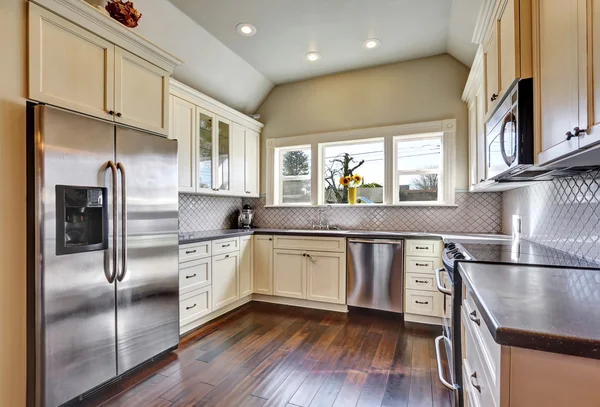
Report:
533,0,600,165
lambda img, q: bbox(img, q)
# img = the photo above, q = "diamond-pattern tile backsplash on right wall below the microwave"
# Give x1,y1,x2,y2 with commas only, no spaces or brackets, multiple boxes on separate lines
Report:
502,171,600,262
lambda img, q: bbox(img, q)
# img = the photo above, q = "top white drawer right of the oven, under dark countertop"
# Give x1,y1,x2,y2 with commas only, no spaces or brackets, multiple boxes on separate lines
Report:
463,290,502,392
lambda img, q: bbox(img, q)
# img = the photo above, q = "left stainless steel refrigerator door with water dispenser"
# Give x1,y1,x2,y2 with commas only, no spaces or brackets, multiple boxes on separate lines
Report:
29,106,117,407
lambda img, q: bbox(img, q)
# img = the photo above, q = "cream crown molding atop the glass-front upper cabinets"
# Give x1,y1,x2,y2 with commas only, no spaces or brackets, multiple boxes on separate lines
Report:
170,78,265,133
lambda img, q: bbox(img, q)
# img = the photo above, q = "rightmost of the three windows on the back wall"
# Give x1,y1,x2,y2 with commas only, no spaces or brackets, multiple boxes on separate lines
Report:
394,134,443,203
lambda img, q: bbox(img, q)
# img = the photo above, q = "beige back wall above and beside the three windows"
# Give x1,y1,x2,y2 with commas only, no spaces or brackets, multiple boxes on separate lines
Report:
258,54,469,193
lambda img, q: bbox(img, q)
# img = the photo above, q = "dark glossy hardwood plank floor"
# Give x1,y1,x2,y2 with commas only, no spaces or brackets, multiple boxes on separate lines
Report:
78,302,450,407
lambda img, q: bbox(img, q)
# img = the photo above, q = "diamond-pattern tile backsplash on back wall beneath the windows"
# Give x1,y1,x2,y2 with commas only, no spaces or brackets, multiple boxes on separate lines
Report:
243,192,502,233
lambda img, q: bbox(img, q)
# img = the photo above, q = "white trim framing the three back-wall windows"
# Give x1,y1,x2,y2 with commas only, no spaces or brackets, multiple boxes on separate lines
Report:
266,119,456,207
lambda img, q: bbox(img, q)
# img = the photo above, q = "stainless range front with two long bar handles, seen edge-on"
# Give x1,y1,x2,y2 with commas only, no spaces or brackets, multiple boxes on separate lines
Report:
435,267,458,406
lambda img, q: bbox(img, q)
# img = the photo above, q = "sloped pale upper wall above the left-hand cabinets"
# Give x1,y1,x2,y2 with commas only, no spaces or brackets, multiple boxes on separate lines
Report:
135,0,273,114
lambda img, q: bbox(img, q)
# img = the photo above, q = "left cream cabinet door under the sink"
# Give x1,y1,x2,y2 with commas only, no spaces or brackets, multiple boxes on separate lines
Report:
273,250,306,299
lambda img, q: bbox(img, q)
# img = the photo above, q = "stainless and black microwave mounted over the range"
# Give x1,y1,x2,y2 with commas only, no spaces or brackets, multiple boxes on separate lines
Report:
485,79,536,182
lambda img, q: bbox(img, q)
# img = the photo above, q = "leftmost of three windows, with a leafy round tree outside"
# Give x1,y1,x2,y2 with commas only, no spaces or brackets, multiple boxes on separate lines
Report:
276,146,311,205
